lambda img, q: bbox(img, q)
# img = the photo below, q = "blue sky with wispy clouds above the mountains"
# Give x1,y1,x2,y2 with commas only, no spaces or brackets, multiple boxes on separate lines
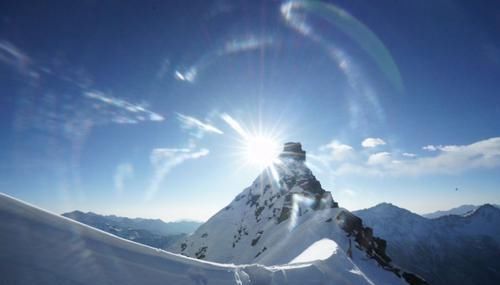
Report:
0,1,500,220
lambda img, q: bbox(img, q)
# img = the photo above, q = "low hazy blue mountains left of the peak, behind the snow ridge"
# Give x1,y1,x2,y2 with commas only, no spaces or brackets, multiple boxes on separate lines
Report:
62,211,200,249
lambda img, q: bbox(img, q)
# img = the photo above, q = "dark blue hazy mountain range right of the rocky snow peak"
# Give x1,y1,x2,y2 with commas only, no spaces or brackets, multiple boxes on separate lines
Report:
354,203,500,285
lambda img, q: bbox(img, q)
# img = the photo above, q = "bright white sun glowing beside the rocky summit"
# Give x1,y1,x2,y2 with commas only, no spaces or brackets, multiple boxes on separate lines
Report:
244,135,280,167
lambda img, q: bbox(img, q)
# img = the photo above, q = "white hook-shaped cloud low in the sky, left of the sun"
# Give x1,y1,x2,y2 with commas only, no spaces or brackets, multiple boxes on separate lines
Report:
146,148,209,200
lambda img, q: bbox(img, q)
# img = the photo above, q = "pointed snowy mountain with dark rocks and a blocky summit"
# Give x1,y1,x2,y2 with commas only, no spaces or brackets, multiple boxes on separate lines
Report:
171,142,426,284
